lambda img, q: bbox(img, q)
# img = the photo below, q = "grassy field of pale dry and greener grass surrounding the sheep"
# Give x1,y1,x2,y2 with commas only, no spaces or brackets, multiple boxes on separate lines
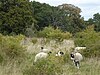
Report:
0,38,100,75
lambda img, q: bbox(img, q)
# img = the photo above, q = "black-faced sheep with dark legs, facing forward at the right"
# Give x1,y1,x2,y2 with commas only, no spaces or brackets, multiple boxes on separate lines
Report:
70,52,83,69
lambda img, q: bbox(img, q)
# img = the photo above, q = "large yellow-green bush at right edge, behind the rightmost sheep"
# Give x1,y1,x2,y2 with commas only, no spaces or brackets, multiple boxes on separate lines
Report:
74,26,100,57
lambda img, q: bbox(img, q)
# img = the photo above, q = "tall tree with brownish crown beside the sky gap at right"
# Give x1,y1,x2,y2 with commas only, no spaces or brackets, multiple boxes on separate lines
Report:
58,4,85,33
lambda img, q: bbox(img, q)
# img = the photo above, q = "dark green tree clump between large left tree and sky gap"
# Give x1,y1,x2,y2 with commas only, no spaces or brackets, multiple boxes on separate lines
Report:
33,1,85,33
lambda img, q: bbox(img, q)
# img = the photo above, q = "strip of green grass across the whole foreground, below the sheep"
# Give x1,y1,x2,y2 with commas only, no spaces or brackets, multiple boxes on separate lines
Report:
0,54,100,75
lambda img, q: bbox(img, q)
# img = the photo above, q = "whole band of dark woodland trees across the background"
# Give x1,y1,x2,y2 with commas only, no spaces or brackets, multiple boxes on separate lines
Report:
0,0,100,36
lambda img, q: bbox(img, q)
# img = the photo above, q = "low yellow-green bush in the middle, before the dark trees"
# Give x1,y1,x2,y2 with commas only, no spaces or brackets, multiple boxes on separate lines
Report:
38,27,72,41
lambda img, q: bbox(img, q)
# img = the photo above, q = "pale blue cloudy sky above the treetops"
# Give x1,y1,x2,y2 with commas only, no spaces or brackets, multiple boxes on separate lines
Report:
30,0,100,20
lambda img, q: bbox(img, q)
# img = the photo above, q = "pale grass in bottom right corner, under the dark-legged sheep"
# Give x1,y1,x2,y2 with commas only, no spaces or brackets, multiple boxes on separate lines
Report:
64,58,100,75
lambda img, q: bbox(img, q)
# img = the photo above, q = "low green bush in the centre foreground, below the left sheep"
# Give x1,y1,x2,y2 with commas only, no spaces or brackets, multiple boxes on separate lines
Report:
23,56,63,75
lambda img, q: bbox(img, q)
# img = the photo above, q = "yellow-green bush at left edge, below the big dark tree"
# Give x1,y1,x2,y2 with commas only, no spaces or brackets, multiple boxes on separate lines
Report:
0,35,25,60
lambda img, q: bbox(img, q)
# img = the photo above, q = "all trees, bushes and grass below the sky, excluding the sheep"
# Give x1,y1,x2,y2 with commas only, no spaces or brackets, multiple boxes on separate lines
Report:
0,0,100,75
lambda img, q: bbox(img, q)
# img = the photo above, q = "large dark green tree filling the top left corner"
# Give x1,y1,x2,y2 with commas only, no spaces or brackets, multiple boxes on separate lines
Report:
0,0,34,34
